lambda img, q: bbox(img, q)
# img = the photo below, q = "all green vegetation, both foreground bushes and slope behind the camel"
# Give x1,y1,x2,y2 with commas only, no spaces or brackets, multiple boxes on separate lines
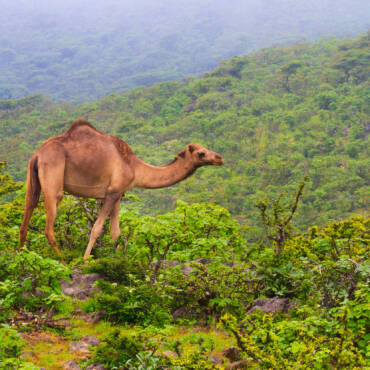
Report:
0,34,370,369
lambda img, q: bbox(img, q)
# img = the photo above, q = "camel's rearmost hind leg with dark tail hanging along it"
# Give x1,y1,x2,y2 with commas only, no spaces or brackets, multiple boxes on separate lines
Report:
19,156,41,248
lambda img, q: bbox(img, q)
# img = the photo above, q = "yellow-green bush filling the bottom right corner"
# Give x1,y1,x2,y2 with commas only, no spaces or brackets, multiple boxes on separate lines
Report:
221,291,370,369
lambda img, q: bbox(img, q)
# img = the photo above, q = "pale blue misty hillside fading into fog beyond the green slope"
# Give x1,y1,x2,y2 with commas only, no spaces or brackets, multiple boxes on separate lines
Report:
0,0,370,103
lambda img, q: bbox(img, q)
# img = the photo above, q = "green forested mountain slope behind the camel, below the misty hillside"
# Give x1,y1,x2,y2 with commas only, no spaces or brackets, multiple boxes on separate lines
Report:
0,34,370,238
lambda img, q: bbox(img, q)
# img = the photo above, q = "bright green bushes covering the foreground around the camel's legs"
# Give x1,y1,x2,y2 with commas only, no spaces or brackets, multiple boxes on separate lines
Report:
0,160,370,369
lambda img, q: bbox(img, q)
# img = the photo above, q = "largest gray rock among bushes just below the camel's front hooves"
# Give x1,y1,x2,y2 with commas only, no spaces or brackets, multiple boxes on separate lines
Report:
60,272,101,300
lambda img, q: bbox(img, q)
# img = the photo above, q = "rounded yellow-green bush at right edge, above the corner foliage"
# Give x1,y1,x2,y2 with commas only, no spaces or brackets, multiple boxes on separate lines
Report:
284,217,370,308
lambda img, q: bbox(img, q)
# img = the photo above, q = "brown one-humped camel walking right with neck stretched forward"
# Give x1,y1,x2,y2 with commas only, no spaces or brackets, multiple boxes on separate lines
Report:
19,119,223,260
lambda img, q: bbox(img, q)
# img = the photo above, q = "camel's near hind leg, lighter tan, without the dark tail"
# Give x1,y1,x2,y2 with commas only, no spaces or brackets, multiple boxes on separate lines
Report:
39,146,65,256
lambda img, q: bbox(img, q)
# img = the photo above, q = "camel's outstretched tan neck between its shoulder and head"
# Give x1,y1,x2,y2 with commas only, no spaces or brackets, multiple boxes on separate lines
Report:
133,157,196,189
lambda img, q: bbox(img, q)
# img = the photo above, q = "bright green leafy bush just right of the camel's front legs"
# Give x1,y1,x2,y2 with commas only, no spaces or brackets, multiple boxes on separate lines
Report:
122,201,243,268
